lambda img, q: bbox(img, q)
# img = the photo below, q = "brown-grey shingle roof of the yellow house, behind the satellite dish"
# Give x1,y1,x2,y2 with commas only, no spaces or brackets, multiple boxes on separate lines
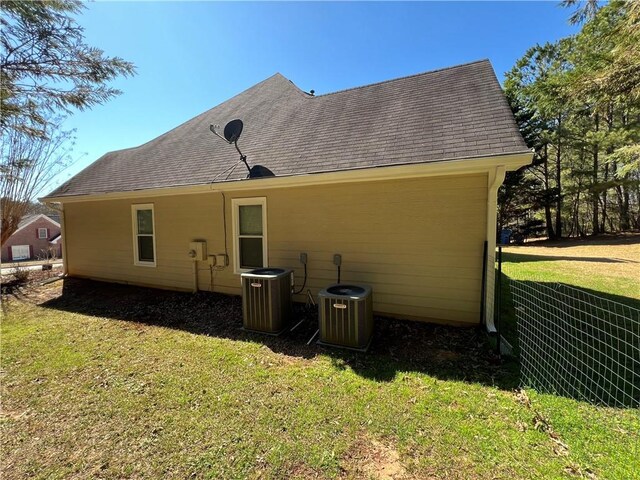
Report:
49,60,527,197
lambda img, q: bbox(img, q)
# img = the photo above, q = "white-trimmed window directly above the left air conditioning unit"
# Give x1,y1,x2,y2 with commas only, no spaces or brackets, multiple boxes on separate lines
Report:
232,197,268,273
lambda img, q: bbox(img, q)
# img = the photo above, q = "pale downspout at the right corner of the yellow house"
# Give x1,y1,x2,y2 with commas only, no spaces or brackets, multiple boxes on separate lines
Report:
484,165,506,333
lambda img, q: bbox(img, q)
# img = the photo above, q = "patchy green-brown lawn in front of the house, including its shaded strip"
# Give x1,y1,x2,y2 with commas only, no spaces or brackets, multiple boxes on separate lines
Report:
1,280,640,479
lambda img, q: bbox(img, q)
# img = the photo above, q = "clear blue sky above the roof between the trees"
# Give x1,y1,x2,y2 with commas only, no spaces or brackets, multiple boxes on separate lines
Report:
51,1,576,191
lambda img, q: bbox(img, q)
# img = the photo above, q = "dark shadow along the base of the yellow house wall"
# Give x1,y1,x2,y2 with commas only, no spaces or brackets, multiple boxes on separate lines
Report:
41,278,518,390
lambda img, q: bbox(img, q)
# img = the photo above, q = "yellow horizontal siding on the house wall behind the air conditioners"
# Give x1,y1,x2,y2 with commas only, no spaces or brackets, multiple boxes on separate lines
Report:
64,174,487,323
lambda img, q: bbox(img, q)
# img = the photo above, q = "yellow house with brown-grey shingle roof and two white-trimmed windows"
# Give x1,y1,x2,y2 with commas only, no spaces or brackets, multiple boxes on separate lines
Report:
42,60,532,330
